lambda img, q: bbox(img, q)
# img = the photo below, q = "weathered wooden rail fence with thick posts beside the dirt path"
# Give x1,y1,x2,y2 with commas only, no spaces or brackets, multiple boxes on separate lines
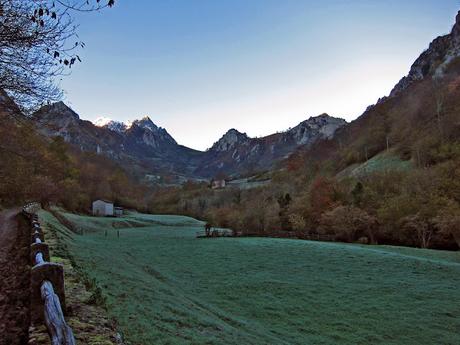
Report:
22,203,75,345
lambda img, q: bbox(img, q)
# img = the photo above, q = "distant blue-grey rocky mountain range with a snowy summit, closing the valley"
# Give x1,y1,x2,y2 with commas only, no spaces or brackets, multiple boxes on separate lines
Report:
32,102,346,182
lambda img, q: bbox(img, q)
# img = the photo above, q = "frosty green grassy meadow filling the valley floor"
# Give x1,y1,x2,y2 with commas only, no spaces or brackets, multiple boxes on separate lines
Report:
41,208,460,345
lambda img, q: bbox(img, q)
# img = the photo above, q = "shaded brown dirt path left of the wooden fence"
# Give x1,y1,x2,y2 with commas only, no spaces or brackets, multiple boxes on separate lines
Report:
0,209,30,345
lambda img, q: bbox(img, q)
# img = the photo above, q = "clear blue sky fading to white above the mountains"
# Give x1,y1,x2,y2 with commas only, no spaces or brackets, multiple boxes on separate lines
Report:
61,0,460,149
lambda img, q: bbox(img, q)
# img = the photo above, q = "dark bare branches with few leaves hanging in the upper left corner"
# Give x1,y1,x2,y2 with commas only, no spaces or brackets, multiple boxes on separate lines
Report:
0,0,114,110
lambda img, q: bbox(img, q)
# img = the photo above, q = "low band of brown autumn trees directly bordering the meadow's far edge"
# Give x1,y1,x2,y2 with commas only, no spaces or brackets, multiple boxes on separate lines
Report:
149,157,460,249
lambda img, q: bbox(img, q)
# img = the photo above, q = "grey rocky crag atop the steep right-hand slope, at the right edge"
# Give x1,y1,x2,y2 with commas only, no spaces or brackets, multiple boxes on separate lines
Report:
389,11,460,97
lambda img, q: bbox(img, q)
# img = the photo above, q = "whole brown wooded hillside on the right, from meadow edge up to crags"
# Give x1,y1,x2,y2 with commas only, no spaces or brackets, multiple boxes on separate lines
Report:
148,59,460,249
